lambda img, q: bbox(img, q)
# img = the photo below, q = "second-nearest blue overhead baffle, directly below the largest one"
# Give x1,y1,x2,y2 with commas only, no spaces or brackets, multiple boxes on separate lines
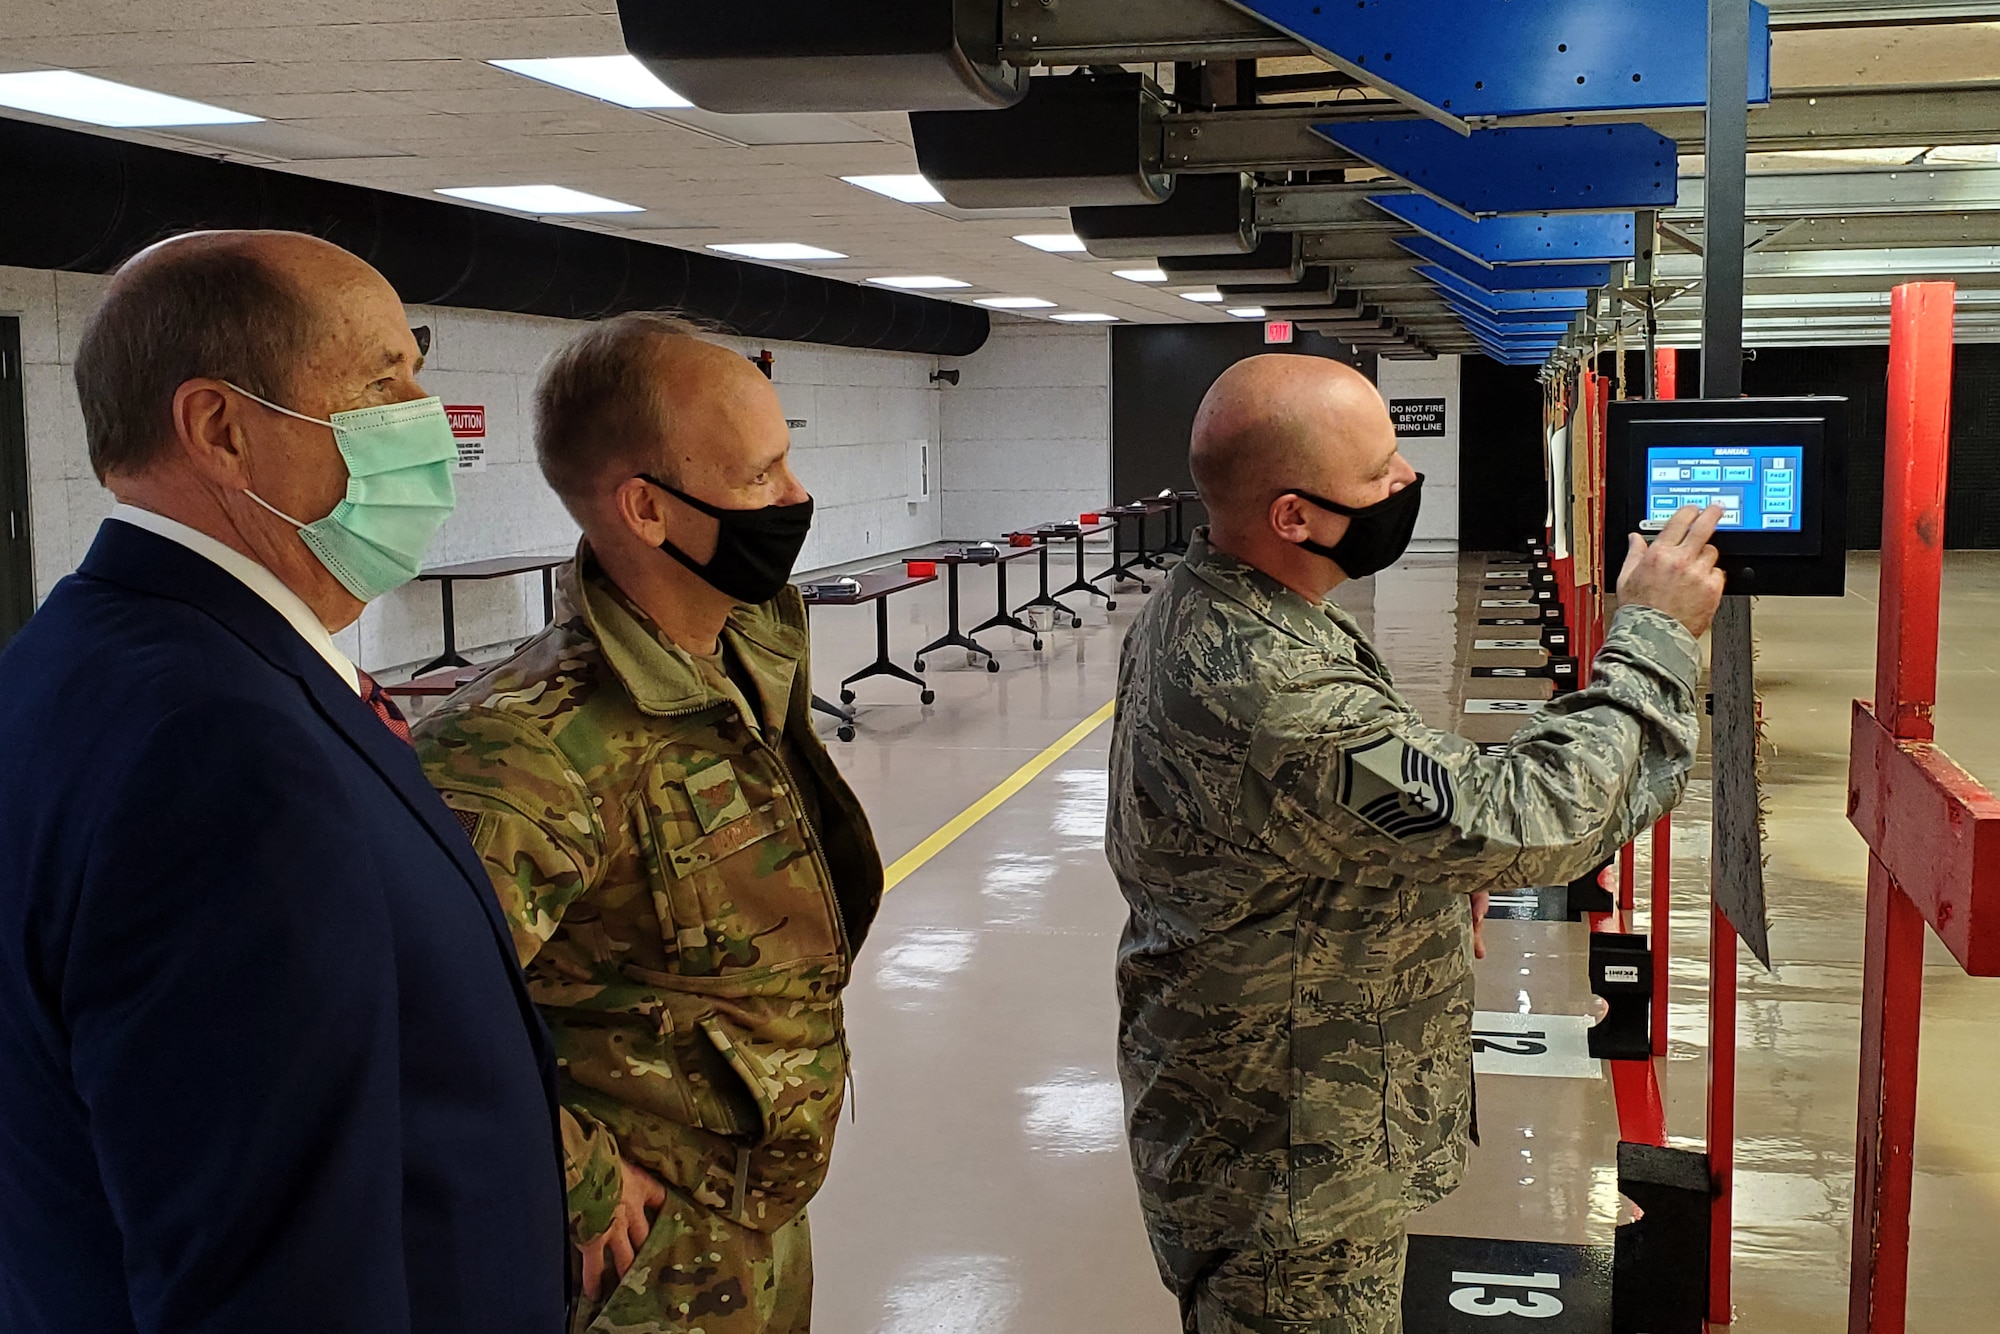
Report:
1312,120,1680,218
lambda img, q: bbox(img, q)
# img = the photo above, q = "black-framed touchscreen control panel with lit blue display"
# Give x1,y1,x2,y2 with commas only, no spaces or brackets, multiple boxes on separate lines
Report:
1604,398,1848,598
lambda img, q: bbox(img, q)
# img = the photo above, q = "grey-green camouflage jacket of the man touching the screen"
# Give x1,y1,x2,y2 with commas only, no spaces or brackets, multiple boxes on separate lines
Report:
1106,532,1698,1250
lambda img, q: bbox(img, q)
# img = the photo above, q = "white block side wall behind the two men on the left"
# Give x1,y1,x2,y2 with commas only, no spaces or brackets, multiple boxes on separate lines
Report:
0,266,952,676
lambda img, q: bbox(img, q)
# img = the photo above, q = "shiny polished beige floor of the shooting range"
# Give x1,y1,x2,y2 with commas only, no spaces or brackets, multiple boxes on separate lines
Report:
784,556,2000,1334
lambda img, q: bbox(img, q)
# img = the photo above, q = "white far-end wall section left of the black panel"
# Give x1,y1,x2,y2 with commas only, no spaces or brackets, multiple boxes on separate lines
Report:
940,318,1112,538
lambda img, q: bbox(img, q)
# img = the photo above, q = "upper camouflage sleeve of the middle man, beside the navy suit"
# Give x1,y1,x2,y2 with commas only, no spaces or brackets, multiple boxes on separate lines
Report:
404,708,604,968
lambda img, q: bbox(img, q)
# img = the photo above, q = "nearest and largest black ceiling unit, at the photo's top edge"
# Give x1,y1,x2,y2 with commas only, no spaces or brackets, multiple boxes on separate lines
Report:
618,0,1028,112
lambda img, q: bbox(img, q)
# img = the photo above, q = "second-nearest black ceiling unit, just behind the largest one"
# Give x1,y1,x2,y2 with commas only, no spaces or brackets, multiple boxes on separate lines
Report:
910,70,1174,208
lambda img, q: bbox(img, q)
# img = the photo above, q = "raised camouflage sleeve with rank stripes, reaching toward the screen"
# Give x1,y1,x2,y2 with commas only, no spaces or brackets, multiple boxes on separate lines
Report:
1238,606,1700,892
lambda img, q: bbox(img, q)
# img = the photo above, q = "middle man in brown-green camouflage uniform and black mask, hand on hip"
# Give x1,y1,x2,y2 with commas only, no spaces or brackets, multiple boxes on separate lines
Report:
416,316,882,1334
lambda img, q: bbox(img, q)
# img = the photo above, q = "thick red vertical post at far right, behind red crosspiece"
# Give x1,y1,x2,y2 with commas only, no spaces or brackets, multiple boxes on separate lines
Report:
1848,282,1954,1334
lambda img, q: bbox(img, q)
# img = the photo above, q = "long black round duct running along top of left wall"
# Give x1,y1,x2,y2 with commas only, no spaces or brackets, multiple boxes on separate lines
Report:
0,120,988,356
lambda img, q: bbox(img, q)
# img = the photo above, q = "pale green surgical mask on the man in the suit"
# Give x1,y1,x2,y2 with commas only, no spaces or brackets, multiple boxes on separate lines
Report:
224,380,458,602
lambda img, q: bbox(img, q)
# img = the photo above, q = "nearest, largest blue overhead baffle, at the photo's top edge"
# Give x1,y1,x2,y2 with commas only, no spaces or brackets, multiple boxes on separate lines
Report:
1230,0,1770,128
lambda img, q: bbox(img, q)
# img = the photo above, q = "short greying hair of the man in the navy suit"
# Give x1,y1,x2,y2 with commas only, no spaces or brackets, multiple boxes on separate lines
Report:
76,238,316,482
